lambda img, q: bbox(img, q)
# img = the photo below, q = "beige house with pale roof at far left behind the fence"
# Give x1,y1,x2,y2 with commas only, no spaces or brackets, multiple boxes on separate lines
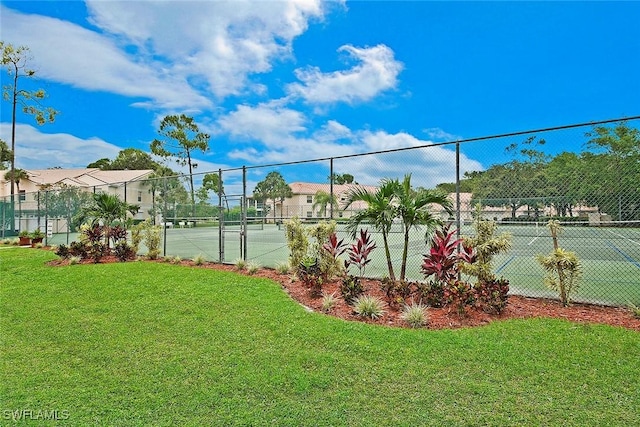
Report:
0,168,153,232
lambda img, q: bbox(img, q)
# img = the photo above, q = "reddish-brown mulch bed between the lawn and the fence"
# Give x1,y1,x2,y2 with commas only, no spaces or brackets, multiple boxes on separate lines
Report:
50,252,640,331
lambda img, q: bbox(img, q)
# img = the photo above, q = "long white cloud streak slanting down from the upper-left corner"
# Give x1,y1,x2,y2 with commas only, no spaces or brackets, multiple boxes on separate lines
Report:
2,7,210,108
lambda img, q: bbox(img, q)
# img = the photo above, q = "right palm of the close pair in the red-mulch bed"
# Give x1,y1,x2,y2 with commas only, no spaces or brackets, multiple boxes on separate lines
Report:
395,174,453,280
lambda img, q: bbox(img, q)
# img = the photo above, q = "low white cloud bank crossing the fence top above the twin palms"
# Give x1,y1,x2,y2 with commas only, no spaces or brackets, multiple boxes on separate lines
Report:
215,104,482,187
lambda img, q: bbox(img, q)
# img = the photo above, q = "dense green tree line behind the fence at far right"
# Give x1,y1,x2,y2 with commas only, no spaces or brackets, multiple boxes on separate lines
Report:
437,122,640,221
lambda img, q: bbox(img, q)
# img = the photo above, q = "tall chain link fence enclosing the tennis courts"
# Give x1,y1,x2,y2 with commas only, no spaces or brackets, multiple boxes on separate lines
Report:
0,117,640,305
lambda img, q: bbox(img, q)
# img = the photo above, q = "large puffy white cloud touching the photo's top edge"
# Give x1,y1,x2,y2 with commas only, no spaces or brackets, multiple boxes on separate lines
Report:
87,0,327,97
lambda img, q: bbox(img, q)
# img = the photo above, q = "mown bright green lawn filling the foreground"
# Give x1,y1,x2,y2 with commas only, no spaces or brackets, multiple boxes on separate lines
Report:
0,248,640,426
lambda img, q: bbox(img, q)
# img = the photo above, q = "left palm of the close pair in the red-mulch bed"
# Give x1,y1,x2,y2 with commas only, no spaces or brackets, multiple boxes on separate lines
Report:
345,179,400,280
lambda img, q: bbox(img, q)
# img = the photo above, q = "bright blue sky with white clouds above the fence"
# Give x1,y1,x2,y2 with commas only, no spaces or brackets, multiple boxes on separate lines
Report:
0,0,640,190
